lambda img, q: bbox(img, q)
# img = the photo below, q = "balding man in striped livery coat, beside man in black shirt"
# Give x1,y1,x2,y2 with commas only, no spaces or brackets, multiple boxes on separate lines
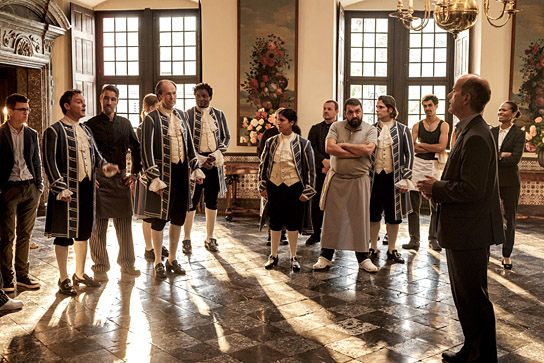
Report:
141,79,204,279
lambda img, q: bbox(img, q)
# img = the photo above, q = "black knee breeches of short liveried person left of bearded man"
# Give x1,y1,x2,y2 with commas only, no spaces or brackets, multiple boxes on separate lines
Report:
266,182,304,231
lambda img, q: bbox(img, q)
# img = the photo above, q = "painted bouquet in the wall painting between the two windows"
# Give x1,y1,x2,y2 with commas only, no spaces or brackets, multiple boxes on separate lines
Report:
241,34,293,112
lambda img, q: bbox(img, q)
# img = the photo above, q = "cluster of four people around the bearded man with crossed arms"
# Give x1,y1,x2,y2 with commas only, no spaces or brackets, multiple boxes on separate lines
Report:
259,96,413,273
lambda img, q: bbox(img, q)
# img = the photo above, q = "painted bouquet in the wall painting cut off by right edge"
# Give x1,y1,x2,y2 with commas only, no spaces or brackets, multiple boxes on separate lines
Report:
519,39,544,116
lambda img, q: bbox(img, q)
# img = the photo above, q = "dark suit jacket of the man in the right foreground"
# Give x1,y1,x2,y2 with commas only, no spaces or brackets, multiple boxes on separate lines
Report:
432,115,504,250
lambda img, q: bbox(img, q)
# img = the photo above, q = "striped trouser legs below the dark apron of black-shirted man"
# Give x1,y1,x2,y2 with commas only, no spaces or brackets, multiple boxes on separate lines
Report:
89,217,136,272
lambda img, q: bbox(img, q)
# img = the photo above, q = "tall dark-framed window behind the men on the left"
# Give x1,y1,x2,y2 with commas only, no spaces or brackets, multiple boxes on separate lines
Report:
97,10,200,127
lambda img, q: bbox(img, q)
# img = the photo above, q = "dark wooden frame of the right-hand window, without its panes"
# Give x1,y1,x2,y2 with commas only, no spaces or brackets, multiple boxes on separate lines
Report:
344,11,455,130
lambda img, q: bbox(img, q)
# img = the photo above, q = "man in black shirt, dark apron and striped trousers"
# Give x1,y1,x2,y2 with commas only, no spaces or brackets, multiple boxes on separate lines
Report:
85,84,142,281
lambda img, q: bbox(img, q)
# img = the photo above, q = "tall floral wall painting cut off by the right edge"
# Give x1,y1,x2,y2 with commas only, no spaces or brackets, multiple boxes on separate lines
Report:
510,0,544,152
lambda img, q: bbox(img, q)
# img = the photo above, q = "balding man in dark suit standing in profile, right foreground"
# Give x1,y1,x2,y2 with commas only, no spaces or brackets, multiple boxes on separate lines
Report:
418,75,504,362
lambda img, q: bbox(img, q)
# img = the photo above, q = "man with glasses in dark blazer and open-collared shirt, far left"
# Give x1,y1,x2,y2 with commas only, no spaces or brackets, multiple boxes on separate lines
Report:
0,93,43,292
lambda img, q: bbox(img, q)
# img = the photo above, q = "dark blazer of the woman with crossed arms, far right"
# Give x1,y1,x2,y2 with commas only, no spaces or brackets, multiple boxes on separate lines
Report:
491,125,525,187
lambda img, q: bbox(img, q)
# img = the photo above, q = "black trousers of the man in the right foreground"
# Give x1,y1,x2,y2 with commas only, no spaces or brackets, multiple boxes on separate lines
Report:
446,247,497,363
